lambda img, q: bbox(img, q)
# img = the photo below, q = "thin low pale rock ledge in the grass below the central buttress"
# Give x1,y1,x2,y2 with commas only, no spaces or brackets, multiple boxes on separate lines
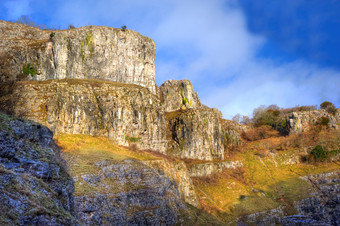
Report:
189,161,243,177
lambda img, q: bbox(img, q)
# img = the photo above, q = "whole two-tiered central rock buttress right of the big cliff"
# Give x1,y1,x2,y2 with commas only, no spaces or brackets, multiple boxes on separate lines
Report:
159,80,224,160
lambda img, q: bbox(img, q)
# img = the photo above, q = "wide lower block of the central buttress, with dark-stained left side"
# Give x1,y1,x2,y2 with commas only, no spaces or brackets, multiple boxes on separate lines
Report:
167,107,224,161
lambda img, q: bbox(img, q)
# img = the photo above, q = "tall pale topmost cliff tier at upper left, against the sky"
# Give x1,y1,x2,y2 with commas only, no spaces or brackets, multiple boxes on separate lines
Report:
0,21,156,93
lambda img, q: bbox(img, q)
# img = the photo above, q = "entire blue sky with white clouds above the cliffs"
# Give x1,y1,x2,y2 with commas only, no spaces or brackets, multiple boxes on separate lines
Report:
0,0,340,118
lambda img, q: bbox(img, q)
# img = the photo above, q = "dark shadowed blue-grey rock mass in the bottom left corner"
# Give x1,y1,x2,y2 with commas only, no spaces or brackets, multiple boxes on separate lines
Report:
0,114,77,225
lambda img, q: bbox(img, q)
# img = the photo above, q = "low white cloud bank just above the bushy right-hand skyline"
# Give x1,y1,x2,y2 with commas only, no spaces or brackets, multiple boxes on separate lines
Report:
203,61,340,118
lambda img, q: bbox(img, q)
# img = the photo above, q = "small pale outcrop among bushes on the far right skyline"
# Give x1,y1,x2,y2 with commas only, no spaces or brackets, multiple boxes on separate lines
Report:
287,109,340,134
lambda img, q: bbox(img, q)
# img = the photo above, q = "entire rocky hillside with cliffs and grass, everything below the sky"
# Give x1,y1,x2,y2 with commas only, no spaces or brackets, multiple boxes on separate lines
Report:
0,21,340,225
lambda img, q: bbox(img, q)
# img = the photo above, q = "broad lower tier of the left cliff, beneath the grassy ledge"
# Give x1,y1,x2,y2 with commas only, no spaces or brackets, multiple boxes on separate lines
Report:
0,79,167,153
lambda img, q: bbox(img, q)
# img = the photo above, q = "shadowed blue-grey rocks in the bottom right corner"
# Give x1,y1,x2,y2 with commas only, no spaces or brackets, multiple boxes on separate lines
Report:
241,171,340,226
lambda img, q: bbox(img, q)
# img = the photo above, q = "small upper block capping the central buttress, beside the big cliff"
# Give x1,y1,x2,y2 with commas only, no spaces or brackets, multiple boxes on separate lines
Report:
159,80,202,112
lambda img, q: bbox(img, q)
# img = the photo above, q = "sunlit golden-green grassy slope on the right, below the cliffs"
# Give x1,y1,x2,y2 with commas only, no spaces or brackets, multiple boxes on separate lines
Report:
193,132,340,222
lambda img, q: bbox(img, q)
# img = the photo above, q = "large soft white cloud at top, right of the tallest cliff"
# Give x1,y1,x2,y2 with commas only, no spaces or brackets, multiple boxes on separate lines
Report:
153,0,264,81
